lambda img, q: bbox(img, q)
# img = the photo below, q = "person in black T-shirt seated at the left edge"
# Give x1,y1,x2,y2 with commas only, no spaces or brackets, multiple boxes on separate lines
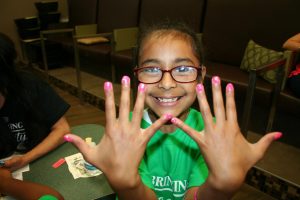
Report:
0,33,70,171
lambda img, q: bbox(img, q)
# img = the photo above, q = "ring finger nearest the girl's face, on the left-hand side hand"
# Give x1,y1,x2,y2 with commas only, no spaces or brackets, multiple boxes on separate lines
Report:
132,83,146,125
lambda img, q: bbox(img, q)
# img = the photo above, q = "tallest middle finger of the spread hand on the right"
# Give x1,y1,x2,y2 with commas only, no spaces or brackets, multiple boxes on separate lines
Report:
211,76,225,123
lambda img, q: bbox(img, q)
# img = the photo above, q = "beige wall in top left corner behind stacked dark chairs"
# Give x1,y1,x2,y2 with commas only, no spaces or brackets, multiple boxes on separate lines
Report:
0,0,68,61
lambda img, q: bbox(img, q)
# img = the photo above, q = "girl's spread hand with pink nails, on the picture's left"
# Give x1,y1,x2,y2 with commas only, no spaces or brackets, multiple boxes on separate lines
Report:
65,76,171,190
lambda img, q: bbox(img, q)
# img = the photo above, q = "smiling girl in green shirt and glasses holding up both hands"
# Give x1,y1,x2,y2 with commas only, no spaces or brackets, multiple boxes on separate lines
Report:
65,22,281,200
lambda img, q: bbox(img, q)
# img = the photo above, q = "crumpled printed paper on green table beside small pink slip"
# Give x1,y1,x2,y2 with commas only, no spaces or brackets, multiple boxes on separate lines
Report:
65,153,102,179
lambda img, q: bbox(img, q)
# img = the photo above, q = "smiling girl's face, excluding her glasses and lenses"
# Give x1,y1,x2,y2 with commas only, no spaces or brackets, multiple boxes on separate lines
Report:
139,33,204,123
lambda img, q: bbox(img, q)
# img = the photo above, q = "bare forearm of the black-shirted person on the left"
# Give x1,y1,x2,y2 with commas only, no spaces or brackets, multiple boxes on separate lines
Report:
5,117,70,171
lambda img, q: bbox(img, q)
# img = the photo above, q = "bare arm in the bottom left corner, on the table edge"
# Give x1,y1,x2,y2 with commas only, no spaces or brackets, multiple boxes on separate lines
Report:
0,168,64,200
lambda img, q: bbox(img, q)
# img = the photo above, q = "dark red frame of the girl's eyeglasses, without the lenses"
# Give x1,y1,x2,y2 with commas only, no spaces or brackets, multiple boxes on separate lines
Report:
133,65,202,84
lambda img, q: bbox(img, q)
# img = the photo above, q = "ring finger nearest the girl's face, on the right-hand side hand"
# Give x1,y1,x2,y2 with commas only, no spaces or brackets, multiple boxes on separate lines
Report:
196,83,213,130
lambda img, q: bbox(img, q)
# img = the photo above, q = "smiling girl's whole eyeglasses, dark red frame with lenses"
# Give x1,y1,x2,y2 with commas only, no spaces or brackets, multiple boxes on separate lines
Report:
134,65,202,84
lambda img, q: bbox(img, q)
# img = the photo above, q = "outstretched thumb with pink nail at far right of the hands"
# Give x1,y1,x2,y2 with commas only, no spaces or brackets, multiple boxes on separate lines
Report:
255,132,282,159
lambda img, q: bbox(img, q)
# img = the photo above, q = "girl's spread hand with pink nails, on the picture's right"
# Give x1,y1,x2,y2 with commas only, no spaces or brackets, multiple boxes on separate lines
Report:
171,77,281,193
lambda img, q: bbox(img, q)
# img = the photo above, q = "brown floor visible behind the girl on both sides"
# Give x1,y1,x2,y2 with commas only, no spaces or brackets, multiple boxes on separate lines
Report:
40,67,300,200
